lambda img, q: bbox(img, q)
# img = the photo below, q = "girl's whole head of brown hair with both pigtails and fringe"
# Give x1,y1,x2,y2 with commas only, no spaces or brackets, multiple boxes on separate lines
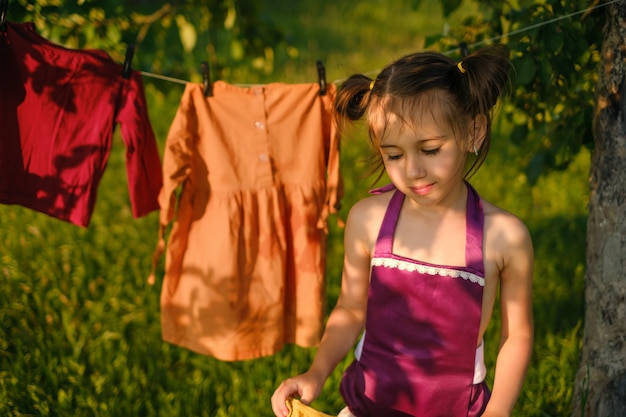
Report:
335,44,511,181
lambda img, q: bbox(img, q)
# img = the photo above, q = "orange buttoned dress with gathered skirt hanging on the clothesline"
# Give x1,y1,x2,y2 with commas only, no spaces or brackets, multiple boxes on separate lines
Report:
159,81,341,361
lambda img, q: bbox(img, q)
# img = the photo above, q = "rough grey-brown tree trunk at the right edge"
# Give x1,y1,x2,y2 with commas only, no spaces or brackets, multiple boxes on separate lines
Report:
572,0,626,417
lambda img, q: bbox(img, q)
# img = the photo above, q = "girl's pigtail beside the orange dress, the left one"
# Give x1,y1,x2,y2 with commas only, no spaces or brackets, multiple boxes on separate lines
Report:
335,74,374,129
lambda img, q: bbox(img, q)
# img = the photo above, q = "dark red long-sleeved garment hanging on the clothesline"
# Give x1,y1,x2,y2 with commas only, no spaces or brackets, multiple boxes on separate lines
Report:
0,23,162,227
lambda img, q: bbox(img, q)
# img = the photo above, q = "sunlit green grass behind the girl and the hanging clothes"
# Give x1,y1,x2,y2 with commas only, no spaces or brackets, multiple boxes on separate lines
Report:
0,0,589,417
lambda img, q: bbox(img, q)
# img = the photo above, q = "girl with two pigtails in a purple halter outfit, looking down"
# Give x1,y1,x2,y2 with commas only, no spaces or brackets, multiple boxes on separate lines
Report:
272,45,533,417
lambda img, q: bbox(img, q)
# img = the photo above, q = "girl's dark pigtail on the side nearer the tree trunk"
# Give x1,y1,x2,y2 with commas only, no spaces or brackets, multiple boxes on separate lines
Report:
449,44,511,116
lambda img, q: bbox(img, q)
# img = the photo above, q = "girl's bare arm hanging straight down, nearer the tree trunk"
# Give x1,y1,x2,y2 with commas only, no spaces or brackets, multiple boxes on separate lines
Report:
483,215,534,417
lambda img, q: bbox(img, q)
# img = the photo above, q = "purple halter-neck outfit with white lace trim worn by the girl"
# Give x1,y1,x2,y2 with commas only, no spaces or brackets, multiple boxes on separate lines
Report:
340,184,490,417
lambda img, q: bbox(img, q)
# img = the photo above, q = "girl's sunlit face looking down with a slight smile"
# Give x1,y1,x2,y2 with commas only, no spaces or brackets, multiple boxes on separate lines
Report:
379,105,467,206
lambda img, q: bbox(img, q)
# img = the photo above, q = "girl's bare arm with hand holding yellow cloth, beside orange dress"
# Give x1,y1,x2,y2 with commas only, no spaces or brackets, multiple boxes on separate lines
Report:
272,200,371,417
